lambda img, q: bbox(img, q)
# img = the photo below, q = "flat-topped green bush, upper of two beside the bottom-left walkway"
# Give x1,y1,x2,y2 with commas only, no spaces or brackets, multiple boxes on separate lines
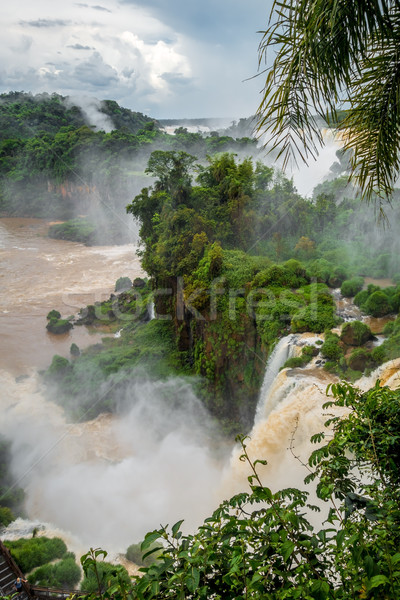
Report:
4,537,67,573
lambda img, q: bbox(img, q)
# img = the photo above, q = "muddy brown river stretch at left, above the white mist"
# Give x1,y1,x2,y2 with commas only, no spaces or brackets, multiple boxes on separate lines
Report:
0,218,143,376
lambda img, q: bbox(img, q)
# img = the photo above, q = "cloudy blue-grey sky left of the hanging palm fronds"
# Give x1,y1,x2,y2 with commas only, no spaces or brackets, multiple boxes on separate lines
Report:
0,0,271,119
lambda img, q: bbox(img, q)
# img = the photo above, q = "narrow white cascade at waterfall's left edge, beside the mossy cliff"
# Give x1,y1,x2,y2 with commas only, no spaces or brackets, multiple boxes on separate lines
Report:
255,334,298,423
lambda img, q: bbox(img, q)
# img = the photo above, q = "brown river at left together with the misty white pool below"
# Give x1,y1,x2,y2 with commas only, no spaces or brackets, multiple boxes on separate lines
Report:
0,219,225,552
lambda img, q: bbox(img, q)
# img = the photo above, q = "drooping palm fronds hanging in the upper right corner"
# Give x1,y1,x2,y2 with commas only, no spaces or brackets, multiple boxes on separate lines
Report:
258,0,400,208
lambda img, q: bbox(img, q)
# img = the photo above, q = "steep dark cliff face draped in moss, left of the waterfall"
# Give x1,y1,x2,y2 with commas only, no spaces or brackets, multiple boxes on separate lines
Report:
154,278,267,431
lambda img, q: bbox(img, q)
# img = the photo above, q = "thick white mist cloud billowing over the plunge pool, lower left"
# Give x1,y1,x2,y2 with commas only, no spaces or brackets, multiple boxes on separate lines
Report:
0,373,226,551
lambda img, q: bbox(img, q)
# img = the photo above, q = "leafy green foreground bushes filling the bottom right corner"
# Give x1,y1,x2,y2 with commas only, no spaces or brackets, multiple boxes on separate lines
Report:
86,382,400,600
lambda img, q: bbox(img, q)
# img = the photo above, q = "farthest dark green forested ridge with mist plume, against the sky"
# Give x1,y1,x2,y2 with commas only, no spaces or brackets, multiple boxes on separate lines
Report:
0,92,159,140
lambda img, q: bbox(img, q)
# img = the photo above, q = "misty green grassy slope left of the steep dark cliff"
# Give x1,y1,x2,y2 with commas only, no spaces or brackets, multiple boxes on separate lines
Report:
45,314,190,420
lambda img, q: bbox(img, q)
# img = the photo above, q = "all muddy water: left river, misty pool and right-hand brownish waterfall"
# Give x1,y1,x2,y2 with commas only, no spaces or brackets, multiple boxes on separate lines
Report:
0,219,400,554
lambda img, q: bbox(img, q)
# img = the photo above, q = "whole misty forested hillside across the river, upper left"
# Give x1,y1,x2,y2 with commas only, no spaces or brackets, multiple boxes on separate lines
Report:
0,92,260,244
